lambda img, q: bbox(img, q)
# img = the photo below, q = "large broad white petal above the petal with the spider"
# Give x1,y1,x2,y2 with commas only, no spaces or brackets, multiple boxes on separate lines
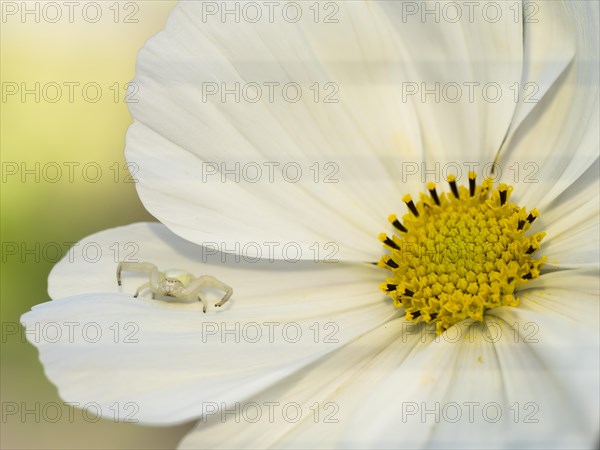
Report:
126,2,524,261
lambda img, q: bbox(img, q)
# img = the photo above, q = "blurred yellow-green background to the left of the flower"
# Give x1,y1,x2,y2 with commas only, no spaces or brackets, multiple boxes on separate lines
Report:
0,0,197,449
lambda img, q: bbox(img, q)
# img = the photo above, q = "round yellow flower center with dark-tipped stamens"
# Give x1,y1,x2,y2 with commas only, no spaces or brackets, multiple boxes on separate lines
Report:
378,172,547,334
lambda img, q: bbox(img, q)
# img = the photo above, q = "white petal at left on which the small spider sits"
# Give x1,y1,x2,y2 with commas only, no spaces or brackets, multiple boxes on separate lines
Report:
22,223,396,424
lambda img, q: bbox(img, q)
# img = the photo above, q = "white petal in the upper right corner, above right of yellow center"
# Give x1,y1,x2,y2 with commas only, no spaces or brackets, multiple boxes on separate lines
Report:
501,2,600,212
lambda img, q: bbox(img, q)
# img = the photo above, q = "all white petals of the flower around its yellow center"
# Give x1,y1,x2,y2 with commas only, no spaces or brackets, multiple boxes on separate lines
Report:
23,2,599,448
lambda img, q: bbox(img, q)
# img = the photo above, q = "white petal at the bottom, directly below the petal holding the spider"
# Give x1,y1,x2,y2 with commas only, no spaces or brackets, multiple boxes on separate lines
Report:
181,319,424,448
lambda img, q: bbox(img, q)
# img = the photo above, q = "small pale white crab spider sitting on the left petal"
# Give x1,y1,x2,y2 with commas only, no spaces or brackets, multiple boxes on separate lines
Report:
117,262,233,312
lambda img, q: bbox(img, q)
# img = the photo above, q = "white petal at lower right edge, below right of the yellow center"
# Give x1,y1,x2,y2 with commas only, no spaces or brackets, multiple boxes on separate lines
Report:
490,267,600,429
